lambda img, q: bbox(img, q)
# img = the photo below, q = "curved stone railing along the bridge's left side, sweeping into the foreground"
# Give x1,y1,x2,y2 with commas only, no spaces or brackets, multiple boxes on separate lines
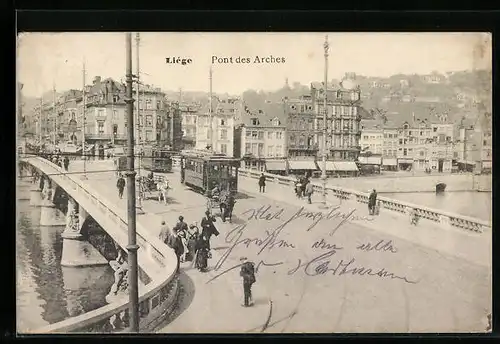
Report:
24,158,179,333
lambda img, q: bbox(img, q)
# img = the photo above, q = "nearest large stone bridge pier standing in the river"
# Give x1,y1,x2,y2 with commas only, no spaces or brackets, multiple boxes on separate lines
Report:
61,197,108,267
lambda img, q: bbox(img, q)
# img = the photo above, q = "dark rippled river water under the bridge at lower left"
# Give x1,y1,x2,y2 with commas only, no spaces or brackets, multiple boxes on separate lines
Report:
16,184,114,333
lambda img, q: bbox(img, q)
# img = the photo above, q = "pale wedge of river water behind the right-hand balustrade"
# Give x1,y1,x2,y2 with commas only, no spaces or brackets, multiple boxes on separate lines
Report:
380,191,492,221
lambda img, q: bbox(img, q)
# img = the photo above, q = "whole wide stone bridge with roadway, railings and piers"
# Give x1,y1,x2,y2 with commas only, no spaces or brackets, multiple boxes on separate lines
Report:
18,157,492,333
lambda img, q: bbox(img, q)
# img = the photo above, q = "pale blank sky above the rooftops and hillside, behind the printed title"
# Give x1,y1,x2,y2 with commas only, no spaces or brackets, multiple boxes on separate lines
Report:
17,32,492,97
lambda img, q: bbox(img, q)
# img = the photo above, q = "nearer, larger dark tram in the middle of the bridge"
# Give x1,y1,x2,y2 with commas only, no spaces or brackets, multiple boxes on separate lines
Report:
181,150,240,195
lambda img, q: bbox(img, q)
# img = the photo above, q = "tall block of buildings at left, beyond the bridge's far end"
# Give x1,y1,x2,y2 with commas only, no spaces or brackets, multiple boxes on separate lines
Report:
24,76,182,149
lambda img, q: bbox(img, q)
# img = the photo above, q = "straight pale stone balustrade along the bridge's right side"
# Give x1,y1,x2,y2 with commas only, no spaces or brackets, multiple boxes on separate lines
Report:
238,168,491,233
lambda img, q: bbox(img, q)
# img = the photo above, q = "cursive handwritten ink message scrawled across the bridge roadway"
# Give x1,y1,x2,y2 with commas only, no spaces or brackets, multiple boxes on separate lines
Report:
207,205,418,284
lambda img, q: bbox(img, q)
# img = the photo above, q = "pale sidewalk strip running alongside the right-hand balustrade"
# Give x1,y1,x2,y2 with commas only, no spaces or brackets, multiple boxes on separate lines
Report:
238,177,492,267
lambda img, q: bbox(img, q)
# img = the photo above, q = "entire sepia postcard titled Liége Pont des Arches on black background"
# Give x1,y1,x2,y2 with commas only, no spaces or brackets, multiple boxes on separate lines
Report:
16,32,493,334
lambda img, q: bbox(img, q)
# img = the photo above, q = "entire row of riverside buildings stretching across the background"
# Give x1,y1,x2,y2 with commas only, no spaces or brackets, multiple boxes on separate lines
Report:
21,76,491,175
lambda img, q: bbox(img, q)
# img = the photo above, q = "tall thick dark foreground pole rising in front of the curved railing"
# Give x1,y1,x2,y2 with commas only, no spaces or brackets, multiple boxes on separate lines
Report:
125,32,139,332
